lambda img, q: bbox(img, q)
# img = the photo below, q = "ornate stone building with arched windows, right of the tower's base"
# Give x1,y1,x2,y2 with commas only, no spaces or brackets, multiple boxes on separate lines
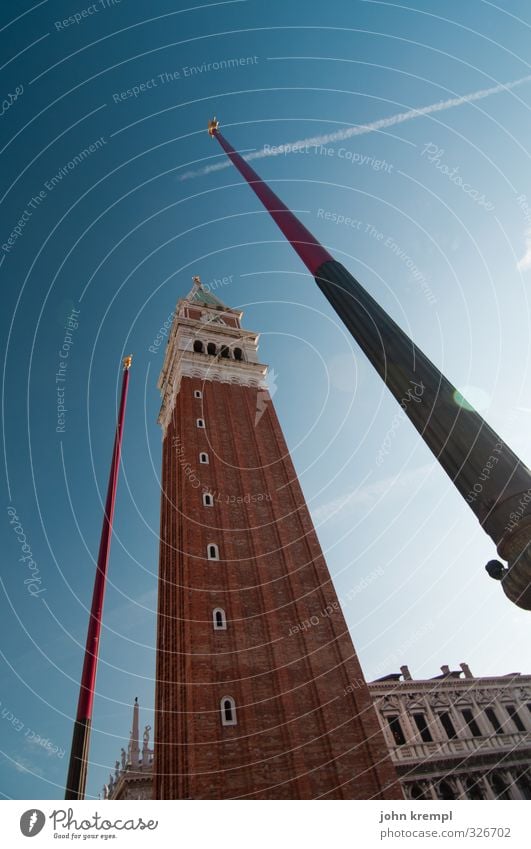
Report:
369,663,531,799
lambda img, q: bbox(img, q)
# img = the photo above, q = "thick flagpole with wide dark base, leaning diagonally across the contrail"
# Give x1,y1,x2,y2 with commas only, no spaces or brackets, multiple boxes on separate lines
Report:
208,118,531,610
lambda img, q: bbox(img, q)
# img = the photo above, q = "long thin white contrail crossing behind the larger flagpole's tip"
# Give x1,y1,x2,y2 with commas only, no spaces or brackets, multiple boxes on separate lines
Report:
179,74,531,180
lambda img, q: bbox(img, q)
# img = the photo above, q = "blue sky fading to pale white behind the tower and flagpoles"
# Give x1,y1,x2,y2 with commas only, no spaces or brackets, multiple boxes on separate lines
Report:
0,0,531,799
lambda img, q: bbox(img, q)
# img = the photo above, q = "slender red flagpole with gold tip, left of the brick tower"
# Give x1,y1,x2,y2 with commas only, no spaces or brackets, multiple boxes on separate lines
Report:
65,356,132,799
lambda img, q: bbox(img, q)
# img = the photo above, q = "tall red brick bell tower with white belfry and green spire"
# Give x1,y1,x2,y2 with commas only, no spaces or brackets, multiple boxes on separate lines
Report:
154,277,402,799
